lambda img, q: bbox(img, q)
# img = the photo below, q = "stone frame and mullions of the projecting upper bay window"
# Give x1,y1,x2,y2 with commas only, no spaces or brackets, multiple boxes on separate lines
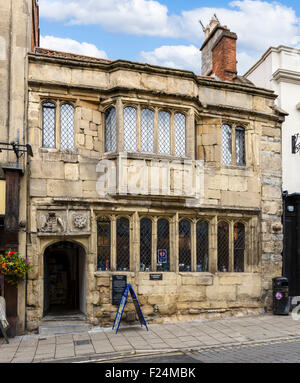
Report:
102,98,189,159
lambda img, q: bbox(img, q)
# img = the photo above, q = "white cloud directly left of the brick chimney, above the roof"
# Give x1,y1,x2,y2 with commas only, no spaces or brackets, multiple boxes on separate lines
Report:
140,45,201,74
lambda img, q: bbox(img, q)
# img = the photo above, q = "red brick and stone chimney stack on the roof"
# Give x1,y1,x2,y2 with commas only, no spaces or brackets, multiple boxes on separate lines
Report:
200,17,237,81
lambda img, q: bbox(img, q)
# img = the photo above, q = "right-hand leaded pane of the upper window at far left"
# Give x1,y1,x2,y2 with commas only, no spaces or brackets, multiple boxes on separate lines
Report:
60,104,74,149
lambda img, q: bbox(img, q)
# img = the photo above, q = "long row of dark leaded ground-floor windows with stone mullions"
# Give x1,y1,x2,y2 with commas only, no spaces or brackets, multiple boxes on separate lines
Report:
97,213,250,272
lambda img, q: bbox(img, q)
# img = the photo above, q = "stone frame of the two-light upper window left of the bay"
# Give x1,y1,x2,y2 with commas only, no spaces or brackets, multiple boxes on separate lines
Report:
40,97,77,152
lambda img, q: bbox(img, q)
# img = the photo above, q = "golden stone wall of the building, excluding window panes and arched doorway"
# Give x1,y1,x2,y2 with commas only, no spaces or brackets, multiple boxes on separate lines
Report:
27,55,282,330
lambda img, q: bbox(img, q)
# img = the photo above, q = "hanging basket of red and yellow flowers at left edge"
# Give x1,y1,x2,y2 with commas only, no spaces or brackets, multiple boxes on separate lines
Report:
0,251,32,286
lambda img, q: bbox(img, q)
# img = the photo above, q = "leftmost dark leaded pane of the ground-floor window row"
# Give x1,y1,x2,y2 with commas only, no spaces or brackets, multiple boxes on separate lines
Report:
97,217,111,271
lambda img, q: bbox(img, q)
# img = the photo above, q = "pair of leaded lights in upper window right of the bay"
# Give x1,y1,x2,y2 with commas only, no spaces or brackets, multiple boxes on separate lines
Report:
222,125,246,166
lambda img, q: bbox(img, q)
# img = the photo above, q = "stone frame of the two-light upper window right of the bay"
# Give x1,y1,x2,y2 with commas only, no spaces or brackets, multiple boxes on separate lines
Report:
220,119,250,169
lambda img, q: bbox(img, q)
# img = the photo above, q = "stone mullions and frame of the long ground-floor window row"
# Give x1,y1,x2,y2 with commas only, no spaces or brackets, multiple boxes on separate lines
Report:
96,212,251,274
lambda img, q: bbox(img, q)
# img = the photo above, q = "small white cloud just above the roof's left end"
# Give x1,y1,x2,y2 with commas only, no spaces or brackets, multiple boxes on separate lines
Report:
40,36,107,59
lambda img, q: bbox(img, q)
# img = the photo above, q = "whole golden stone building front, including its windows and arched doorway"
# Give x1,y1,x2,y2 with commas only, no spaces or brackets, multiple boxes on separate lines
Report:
0,3,284,330
